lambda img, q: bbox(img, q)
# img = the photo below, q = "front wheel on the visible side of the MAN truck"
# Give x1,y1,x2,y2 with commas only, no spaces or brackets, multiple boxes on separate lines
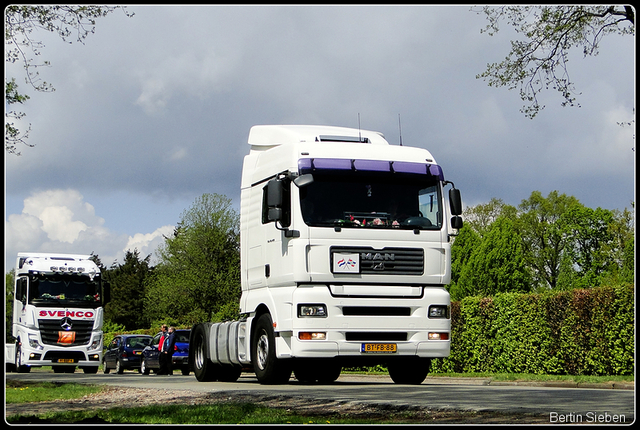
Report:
251,314,291,384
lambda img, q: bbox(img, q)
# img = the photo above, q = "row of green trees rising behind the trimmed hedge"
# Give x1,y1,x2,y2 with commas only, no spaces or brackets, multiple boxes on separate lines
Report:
448,191,635,300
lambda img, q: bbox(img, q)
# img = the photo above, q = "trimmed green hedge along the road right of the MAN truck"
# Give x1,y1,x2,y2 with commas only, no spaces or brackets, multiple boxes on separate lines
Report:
431,285,635,376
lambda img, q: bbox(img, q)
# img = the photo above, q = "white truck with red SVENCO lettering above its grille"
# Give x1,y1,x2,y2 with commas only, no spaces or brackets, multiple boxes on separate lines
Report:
5,252,108,373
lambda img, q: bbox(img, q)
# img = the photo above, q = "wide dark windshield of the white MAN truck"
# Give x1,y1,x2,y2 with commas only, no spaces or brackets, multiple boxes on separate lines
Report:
300,171,442,230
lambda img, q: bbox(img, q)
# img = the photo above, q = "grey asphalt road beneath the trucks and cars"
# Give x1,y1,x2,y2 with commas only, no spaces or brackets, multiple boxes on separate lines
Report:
6,371,635,424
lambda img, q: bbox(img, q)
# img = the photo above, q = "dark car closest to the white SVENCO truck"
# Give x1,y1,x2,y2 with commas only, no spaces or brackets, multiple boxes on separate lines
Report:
102,334,153,373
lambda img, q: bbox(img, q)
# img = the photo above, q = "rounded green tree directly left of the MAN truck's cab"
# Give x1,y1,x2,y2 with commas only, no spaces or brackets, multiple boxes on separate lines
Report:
145,194,241,325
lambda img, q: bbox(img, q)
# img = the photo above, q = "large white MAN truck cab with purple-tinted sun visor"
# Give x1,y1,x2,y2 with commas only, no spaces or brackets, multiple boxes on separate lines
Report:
190,125,462,384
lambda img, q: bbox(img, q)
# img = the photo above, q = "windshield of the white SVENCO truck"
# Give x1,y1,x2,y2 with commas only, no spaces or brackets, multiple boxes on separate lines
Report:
29,274,101,307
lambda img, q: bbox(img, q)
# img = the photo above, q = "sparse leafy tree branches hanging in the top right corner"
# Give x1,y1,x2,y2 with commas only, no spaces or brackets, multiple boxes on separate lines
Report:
476,5,635,118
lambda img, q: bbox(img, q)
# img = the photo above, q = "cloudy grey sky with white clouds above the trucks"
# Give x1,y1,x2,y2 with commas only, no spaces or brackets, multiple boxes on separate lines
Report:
5,6,635,271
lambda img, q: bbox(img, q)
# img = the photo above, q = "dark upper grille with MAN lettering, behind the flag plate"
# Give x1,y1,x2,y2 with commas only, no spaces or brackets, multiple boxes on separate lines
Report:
330,246,424,275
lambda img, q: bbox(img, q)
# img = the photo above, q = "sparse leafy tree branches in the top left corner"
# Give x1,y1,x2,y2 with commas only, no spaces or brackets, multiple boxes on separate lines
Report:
4,5,133,155
